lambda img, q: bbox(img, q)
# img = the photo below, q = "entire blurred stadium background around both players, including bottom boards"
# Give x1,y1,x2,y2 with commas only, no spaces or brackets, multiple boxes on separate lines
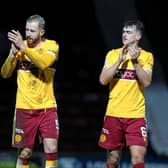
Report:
0,0,168,168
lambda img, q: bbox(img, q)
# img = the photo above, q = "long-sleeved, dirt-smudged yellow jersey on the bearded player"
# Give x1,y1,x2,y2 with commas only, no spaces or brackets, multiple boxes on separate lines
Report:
1,39,59,109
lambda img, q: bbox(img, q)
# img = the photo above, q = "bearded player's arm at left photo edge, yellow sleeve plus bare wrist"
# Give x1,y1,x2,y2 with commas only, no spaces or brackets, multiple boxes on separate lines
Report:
1,44,17,78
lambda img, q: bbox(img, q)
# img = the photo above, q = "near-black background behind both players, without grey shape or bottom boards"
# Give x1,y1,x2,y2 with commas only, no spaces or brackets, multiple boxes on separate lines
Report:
0,0,168,156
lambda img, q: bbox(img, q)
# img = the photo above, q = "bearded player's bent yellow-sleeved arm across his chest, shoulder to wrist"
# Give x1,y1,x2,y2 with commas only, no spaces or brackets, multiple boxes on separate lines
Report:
24,44,59,70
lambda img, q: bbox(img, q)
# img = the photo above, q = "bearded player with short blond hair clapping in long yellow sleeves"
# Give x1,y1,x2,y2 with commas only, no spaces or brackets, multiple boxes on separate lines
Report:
1,15,59,168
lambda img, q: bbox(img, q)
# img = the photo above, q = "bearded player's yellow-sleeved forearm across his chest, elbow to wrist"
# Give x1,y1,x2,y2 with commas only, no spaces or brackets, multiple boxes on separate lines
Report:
24,48,57,70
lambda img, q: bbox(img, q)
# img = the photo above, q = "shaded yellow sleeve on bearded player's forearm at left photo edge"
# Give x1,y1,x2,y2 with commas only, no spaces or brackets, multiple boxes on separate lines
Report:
1,55,17,78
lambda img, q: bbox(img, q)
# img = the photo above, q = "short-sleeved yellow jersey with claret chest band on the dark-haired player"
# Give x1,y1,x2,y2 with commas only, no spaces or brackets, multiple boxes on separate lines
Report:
104,48,154,118
